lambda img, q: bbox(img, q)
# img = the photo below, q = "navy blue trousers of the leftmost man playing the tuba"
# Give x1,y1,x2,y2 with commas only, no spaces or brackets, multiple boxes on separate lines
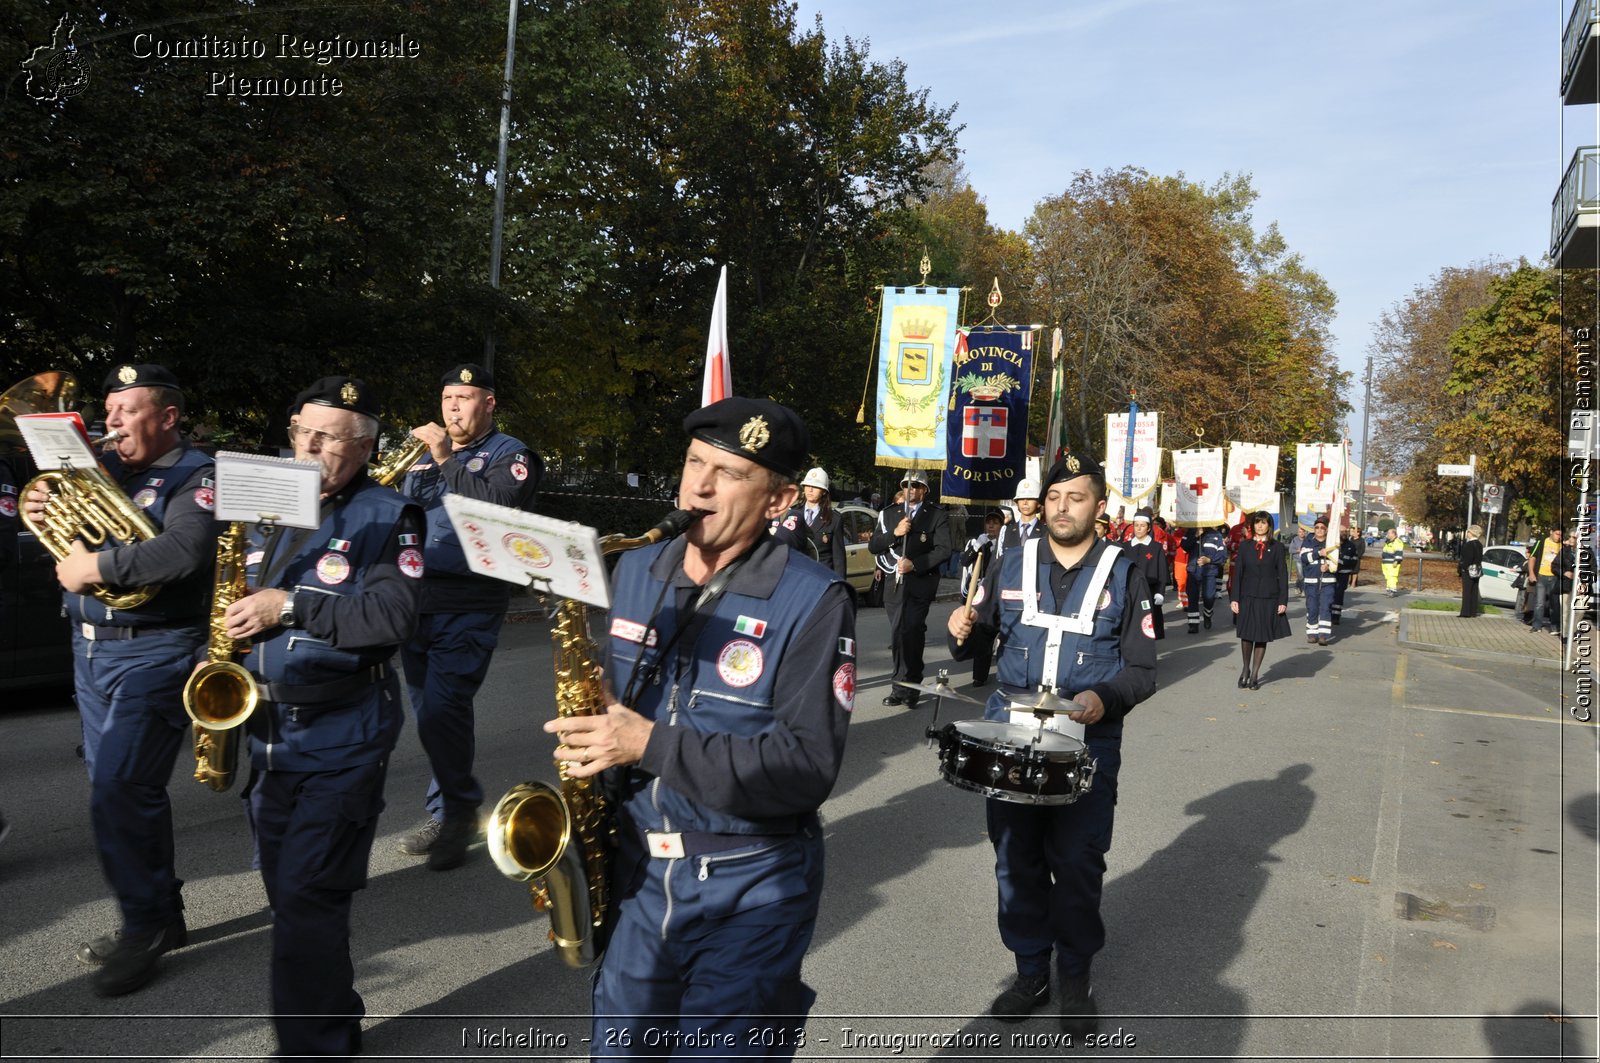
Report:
72,631,202,933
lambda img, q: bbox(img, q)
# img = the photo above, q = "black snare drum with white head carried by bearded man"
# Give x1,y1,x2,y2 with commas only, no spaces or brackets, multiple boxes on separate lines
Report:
930,720,1094,805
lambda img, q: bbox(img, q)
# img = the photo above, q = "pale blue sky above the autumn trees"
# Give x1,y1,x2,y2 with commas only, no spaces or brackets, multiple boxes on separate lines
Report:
797,0,1574,448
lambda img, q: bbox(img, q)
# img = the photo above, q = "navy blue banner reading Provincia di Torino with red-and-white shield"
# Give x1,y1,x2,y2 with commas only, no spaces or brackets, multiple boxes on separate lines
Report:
939,325,1038,503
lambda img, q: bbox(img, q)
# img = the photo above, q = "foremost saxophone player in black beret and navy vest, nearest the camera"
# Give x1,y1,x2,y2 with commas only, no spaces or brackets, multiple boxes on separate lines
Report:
546,399,856,1058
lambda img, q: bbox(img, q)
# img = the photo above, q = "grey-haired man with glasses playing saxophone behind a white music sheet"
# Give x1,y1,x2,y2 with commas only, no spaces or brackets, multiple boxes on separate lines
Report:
224,376,422,1057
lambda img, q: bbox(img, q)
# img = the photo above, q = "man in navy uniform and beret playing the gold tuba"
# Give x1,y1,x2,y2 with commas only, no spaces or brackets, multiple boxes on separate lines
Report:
22,365,216,996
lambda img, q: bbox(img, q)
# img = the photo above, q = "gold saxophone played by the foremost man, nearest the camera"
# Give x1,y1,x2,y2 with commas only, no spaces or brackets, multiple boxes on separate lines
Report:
488,509,701,967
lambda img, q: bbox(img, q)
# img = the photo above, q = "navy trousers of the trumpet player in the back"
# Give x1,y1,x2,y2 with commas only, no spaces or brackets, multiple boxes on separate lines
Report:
400,612,506,820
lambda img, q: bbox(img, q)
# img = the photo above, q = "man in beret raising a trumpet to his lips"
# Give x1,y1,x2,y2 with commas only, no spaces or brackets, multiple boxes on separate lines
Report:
400,363,544,871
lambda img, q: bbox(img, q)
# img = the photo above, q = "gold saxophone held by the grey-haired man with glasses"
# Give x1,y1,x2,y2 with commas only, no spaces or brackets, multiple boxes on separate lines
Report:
184,520,261,794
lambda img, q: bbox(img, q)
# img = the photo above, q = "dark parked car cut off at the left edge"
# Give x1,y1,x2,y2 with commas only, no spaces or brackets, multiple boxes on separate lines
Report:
0,530,72,687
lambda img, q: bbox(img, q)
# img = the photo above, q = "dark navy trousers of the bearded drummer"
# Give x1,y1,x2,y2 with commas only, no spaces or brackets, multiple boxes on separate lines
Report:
986,736,1122,978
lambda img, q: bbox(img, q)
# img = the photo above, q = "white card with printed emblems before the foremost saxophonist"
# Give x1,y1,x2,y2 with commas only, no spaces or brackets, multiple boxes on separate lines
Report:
445,495,611,608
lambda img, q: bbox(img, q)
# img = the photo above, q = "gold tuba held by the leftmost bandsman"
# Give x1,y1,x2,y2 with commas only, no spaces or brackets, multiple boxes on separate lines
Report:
0,370,158,608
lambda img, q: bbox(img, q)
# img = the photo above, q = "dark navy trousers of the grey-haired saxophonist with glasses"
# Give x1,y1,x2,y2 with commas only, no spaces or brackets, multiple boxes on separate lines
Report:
250,759,389,1057
